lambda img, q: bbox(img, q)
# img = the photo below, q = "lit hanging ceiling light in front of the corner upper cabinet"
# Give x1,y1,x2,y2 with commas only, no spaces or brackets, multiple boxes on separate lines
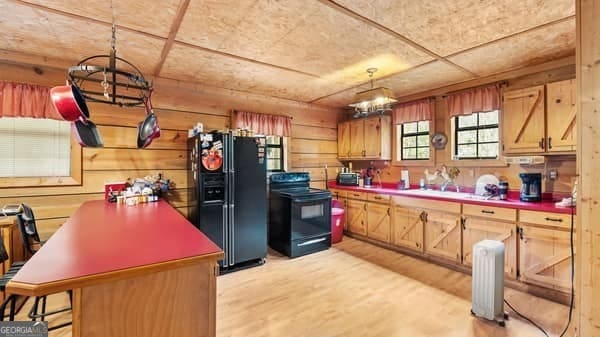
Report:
349,68,396,118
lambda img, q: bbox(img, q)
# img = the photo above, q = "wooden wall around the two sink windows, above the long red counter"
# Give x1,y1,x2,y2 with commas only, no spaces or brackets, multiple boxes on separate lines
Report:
346,65,576,193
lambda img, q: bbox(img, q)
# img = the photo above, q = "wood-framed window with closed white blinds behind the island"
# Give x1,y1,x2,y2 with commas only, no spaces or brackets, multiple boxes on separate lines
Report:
0,117,81,187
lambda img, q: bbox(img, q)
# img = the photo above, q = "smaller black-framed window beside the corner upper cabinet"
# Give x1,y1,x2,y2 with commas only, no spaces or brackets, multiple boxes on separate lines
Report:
397,121,429,160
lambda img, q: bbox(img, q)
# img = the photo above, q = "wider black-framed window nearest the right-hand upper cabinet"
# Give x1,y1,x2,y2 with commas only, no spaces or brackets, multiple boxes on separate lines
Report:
454,110,499,159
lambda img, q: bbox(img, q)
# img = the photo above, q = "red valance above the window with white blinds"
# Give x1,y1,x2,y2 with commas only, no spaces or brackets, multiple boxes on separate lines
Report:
0,82,63,121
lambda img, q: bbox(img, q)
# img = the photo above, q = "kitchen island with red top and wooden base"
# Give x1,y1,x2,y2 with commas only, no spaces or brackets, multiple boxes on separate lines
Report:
7,200,223,337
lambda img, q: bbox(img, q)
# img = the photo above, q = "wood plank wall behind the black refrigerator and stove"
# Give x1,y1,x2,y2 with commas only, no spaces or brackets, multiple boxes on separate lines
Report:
0,62,341,238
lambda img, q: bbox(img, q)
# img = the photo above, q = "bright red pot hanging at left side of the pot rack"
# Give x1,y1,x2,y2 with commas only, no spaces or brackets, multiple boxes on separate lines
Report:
50,84,90,124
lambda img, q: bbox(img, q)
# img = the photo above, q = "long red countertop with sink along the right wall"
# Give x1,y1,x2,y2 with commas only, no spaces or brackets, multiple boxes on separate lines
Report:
328,181,571,214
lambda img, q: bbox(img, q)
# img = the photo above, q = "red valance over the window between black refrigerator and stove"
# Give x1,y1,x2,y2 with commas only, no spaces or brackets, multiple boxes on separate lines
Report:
233,111,292,137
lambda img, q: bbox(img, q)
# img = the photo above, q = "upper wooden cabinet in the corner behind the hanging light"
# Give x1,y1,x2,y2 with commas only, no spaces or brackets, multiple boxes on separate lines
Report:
338,116,392,160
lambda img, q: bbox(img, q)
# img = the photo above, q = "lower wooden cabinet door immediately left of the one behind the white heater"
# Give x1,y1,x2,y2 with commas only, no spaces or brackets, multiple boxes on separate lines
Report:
425,210,461,263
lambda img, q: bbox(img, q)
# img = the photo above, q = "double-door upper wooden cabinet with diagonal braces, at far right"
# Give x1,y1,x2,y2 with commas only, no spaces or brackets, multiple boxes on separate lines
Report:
502,80,577,154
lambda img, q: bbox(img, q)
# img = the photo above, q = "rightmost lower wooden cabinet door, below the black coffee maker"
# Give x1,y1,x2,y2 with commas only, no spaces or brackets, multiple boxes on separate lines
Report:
519,226,571,292
